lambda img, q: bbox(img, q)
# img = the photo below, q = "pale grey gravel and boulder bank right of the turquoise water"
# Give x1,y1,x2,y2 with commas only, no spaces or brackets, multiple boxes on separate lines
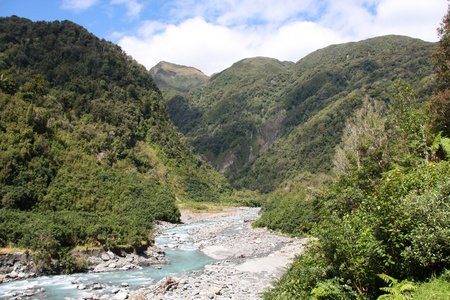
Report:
132,207,306,299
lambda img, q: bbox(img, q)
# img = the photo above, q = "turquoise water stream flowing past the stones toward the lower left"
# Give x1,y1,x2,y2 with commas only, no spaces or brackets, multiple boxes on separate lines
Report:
0,223,213,299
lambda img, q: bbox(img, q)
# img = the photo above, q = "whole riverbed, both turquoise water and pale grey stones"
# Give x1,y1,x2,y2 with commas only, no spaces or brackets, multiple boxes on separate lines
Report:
0,207,306,299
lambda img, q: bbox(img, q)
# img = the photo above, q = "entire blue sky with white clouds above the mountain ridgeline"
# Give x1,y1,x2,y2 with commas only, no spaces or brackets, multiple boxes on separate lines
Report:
0,0,449,75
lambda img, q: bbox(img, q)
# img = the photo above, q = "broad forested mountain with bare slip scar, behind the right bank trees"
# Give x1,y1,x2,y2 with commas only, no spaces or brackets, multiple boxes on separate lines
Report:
163,36,437,192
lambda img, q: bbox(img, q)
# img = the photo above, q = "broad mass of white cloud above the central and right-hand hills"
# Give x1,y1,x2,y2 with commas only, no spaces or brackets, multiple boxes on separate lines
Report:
114,0,447,75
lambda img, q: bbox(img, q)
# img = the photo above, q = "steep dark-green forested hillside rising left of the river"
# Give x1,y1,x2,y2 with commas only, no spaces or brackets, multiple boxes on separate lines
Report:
0,16,231,268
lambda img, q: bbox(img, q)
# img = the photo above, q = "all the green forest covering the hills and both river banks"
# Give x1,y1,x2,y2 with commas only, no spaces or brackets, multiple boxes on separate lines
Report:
0,4,450,299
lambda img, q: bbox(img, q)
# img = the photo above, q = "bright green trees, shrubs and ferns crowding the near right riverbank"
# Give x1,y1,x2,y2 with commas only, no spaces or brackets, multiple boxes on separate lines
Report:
262,5,450,299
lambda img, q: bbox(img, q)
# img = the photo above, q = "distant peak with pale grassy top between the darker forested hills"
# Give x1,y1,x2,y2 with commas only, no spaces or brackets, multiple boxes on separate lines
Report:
150,61,209,92
